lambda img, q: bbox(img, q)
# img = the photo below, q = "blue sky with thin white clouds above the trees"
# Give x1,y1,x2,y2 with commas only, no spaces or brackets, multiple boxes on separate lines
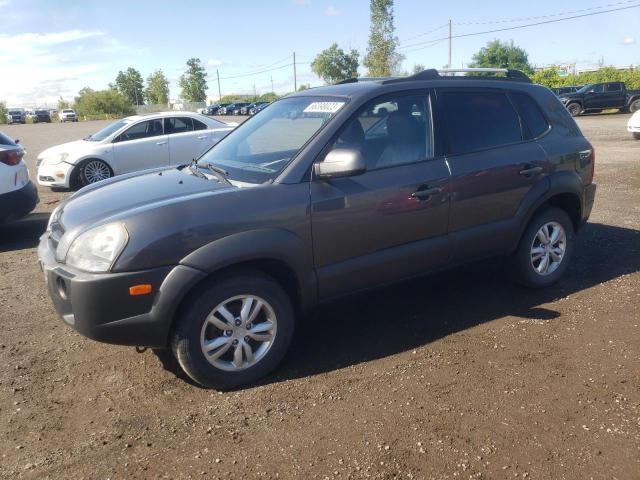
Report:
0,0,640,106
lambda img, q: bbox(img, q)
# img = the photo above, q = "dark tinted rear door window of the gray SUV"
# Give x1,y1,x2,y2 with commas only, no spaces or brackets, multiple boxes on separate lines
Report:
439,90,523,154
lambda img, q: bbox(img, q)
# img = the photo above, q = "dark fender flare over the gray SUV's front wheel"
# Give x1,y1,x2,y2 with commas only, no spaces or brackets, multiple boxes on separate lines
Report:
180,228,318,310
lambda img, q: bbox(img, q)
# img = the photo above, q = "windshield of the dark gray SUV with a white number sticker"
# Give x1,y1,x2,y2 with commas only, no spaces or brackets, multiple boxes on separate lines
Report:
200,97,346,183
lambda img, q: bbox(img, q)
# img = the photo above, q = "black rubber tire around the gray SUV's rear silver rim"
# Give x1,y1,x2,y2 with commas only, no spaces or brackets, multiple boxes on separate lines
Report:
510,207,575,288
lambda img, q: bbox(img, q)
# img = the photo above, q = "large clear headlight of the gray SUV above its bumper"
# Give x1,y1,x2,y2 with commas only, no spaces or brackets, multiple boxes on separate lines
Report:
66,223,129,273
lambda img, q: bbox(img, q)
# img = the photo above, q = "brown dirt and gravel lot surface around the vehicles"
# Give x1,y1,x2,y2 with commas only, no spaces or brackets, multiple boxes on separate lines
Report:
0,115,640,479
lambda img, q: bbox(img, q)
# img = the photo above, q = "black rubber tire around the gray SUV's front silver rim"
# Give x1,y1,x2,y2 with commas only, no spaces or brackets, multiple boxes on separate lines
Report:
171,269,295,390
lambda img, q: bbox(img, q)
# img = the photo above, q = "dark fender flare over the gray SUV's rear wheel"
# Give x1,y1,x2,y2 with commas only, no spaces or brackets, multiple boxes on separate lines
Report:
510,170,583,251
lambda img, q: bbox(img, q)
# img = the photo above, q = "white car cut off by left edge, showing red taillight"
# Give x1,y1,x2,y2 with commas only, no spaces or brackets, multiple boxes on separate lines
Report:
0,132,38,224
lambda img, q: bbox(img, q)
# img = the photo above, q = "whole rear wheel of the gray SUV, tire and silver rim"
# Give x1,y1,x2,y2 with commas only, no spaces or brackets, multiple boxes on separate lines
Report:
511,207,574,288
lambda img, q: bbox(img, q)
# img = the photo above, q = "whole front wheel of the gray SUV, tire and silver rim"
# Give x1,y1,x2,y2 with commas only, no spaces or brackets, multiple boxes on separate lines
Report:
171,270,295,390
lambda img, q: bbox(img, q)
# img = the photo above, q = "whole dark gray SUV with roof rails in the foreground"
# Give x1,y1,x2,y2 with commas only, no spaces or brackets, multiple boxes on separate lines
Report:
39,70,596,389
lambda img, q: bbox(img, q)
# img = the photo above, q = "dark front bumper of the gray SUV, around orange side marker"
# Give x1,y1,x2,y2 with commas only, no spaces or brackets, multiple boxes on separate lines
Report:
38,232,206,348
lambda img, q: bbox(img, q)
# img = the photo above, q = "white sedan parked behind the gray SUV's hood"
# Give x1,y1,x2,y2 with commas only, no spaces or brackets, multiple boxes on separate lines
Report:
36,112,237,188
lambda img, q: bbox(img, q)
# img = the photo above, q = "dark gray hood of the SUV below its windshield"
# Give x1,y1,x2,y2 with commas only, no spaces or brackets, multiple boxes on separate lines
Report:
52,168,237,247
